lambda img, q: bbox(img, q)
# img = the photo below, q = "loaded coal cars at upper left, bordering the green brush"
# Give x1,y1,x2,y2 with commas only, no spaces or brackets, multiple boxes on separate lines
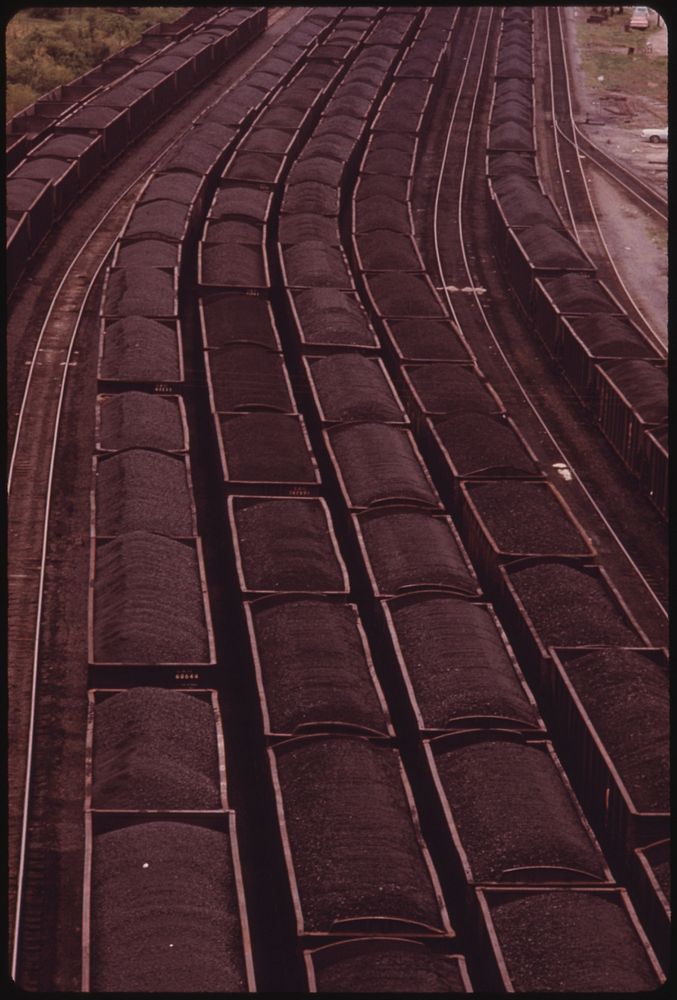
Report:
6,7,267,293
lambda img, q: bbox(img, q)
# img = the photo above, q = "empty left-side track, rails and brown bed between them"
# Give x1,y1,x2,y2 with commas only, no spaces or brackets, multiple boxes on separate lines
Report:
7,7,294,981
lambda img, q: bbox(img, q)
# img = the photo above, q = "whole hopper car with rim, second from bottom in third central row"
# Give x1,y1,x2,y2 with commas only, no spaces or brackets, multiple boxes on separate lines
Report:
424,728,614,900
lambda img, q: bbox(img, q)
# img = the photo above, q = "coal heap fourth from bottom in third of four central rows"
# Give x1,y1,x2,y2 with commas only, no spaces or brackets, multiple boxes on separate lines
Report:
359,510,478,596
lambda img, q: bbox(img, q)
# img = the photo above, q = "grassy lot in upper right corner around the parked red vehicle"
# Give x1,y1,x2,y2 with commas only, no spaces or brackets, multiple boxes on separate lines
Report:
576,7,668,101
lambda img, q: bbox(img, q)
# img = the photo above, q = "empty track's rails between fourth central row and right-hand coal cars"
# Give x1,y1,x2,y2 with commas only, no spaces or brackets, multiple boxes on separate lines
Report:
433,8,668,619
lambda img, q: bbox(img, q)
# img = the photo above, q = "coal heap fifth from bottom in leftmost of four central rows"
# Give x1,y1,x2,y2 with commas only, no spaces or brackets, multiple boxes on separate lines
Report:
99,392,188,451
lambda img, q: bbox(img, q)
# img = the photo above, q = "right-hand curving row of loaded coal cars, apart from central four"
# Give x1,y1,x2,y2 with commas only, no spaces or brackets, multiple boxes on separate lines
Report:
486,7,669,519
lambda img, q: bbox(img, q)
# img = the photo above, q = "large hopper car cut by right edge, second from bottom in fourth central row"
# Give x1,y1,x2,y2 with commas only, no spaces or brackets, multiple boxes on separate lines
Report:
546,645,670,865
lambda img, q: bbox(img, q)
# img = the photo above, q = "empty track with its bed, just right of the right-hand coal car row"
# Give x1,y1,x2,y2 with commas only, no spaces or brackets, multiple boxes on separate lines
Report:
544,7,667,357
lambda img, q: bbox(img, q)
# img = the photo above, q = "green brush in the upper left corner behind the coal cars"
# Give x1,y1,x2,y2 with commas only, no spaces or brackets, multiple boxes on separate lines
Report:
5,7,188,118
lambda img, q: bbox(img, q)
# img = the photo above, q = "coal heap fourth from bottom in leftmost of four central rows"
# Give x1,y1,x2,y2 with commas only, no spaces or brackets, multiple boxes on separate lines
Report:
96,448,195,538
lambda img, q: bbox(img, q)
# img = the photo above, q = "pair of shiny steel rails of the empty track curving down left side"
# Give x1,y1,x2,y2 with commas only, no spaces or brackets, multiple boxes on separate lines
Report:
8,7,294,982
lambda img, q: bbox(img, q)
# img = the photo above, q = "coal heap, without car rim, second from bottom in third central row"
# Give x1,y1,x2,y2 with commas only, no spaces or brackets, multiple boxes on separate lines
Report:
435,739,604,884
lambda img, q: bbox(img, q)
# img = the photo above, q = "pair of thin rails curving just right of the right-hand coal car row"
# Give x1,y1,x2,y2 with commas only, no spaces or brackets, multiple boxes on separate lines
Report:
545,7,667,357
